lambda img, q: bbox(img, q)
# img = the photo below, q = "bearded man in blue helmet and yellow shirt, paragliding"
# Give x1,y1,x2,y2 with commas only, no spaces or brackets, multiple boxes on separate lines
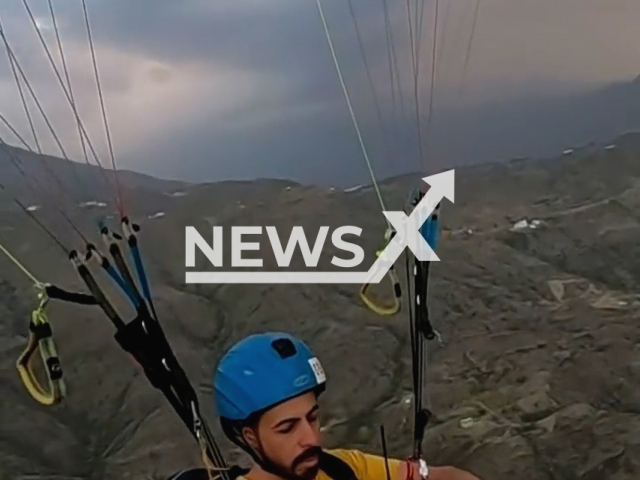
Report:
210,332,479,480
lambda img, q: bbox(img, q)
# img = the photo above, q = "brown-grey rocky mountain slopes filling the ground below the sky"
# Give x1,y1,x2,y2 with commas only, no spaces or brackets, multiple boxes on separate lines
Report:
0,143,640,480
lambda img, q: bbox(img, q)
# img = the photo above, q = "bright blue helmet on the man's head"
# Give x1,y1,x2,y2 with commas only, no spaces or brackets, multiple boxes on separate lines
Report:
213,332,326,422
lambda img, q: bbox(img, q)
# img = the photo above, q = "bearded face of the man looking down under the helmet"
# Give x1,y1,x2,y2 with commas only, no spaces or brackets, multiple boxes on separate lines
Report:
246,392,321,480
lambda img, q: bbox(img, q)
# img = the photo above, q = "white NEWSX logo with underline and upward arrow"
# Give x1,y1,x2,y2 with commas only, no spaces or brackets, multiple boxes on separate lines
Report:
185,170,455,284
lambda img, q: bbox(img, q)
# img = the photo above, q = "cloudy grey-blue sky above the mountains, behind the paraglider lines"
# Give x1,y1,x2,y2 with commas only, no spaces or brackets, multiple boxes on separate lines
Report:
0,0,640,183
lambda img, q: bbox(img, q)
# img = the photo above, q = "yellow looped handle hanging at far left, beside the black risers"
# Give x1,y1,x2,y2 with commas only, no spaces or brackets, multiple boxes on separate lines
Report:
16,284,66,405
